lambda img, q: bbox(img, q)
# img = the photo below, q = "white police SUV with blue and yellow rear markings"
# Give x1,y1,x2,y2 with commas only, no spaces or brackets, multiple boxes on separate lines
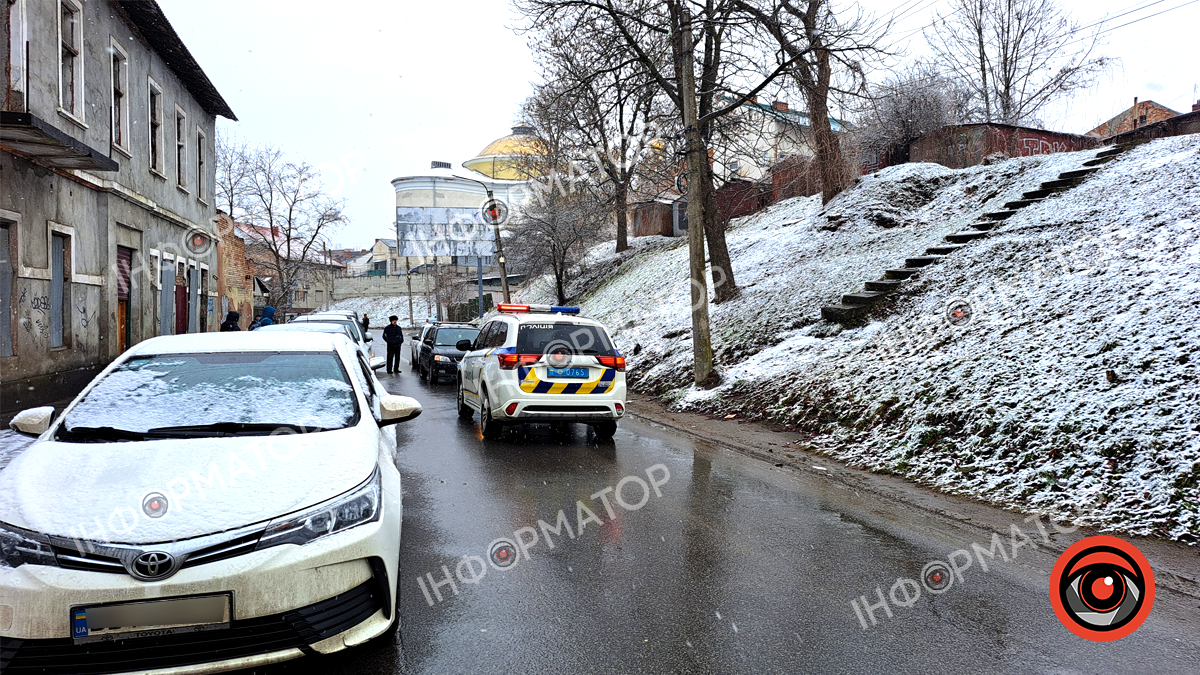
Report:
457,304,625,440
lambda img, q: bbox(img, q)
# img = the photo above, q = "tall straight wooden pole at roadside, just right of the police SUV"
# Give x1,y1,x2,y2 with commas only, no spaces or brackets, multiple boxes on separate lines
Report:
676,7,713,384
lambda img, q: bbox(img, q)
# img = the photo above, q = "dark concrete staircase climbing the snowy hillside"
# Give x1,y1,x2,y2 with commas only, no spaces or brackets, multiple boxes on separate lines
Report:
821,142,1144,323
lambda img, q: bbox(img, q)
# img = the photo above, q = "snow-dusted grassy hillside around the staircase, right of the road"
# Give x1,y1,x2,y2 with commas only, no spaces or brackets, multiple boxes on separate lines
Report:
530,136,1200,543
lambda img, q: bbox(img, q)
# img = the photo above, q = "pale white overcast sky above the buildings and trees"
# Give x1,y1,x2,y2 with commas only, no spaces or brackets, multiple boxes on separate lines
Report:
158,0,1200,246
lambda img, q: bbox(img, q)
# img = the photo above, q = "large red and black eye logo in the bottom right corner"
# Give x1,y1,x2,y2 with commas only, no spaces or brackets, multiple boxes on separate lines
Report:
1050,536,1154,643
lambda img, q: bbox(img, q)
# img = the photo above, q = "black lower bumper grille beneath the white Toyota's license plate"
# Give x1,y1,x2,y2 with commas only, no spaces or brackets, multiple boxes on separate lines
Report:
0,579,383,675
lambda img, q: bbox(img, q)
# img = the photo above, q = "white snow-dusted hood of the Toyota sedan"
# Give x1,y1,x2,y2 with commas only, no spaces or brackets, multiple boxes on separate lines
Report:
0,418,378,544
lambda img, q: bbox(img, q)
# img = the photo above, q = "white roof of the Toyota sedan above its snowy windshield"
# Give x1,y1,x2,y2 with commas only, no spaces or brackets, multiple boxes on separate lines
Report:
128,330,353,356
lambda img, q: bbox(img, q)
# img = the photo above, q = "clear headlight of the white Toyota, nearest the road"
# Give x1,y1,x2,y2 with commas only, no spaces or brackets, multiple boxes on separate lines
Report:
254,466,383,550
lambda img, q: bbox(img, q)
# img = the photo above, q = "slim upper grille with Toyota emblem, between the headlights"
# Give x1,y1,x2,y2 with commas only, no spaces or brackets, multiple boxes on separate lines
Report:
50,525,265,574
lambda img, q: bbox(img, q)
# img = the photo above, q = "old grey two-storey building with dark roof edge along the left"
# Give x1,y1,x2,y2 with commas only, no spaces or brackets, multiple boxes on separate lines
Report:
0,0,236,402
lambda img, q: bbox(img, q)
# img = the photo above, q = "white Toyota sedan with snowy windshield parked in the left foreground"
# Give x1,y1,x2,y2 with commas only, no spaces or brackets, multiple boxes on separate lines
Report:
0,331,421,674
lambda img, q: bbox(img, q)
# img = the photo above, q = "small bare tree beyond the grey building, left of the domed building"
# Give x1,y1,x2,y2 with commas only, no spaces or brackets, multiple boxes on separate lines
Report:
240,148,347,307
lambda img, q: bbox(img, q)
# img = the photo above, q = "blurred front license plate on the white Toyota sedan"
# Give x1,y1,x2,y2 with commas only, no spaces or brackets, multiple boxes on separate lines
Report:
71,593,230,644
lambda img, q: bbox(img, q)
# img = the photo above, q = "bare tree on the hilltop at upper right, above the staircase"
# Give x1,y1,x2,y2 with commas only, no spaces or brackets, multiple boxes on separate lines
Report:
925,0,1112,125
